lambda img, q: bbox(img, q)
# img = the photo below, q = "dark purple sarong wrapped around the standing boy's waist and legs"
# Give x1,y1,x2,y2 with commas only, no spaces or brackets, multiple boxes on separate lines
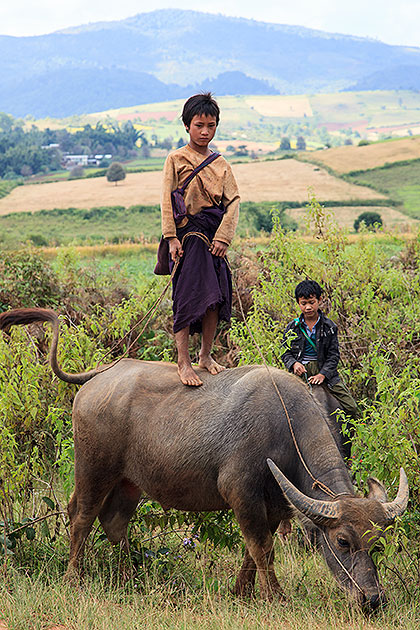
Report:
171,207,232,335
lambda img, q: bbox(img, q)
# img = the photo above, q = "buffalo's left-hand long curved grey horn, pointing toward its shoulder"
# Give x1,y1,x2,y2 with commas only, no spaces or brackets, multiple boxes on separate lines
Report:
267,459,339,525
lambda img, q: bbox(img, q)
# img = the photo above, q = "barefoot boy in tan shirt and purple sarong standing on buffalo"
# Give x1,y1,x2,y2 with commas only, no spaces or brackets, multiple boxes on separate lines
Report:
161,93,239,386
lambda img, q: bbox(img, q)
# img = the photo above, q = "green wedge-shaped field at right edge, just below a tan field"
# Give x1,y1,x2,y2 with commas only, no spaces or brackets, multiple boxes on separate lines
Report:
346,160,420,219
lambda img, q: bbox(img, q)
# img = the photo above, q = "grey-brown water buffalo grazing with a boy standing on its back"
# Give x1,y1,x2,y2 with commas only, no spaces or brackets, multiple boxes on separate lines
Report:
0,309,408,609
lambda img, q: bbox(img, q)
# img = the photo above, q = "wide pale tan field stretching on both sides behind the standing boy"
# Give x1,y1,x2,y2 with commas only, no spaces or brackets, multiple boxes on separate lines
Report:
0,159,382,215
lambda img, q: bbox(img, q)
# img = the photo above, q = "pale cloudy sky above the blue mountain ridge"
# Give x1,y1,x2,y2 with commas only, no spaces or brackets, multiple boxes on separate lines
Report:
0,0,420,46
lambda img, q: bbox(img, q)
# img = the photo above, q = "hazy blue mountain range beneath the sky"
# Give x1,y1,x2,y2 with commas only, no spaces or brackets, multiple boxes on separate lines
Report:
0,9,420,116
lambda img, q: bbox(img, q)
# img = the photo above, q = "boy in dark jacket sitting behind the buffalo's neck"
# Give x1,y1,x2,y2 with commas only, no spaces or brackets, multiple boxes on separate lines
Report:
282,280,358,418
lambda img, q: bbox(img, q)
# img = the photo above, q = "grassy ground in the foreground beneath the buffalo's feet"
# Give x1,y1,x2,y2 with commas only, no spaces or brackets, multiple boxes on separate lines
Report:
0,541,420,630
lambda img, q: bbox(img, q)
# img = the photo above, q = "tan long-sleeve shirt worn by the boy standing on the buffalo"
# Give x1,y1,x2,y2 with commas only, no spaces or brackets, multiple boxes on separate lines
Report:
161,145,239,245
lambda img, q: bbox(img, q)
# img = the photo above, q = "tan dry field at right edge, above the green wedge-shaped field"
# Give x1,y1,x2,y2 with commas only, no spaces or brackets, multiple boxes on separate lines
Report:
311,136,420,173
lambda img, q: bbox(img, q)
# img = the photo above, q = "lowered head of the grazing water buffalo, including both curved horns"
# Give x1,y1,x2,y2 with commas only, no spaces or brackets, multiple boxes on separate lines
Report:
267,459,408,610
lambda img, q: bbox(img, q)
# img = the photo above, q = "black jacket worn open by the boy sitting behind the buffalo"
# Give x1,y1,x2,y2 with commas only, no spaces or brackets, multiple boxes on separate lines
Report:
282,311,340,385
